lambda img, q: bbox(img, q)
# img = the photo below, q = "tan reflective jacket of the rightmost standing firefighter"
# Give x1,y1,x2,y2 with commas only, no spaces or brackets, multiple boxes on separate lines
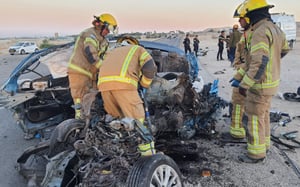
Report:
240,19,289,95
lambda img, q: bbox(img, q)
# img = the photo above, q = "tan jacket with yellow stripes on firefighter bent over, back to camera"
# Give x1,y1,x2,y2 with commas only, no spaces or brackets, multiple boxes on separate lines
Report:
98,45,157,91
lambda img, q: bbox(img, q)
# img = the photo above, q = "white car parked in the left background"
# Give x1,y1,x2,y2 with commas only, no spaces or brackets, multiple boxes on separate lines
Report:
8,41,39,55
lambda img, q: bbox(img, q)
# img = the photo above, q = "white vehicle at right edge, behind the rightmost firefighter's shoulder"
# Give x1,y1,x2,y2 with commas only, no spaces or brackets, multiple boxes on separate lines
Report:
271,13,297,49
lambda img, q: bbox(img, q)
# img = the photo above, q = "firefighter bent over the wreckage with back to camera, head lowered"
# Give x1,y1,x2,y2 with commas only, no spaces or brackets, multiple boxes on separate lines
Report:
98,37,157,156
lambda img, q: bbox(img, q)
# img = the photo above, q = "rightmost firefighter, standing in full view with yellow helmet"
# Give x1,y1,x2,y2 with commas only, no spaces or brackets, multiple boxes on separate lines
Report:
238,0,289,163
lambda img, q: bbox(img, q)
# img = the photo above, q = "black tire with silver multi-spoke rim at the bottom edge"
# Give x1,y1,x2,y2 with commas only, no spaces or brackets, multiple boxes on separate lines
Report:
126,154,183,187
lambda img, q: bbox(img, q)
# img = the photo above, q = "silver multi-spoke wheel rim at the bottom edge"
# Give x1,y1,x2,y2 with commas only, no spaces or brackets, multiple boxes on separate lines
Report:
150,165,182,187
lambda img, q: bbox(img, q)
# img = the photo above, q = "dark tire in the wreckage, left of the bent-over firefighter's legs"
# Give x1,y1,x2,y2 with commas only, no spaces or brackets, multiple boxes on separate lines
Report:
48,119,85,157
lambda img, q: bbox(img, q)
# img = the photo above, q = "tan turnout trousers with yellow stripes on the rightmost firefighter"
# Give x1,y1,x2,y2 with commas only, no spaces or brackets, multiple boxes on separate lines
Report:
245,91,272,159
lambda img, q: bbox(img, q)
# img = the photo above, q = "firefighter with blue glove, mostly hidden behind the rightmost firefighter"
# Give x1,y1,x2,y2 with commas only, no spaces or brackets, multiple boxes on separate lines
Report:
227,4,250,139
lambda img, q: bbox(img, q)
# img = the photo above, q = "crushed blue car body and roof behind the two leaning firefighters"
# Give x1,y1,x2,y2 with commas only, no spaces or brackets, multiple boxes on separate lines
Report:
0,41,203,139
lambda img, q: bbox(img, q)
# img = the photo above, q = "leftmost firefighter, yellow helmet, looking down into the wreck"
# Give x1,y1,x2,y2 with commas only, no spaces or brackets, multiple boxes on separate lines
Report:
68,13,117,119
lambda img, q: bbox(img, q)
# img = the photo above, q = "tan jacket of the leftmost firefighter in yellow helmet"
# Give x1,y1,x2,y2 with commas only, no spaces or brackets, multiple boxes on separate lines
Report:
68,27,108,80
